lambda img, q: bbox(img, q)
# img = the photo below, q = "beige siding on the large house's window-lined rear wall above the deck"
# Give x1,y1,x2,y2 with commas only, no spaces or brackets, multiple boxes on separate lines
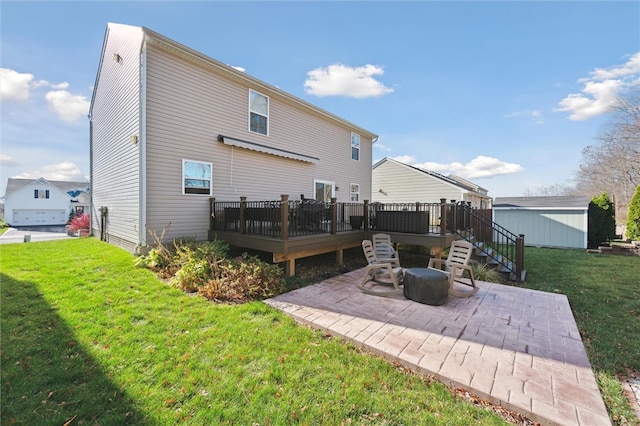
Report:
140,44,371,240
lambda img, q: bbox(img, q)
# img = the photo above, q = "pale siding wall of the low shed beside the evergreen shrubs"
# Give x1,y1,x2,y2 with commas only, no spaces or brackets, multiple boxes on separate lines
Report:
493,209,587,249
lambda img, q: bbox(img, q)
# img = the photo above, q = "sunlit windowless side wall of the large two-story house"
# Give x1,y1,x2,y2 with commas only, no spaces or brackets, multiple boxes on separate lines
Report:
91,25,142,250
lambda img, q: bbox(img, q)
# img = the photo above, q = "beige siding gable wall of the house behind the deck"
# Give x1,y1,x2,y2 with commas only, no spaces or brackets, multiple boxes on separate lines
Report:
371,161,463,203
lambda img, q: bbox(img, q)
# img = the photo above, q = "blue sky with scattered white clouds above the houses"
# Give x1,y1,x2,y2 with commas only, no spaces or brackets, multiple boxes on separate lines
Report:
0,1,640,197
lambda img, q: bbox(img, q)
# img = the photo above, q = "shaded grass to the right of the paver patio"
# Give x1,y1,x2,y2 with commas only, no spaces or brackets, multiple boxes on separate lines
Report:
524,248,640,424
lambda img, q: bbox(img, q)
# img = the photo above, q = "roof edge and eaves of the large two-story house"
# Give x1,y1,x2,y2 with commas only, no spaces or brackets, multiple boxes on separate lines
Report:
89,22,378,143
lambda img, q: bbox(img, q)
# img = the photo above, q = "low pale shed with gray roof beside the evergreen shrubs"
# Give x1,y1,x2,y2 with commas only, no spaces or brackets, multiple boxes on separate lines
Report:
493,197,589,249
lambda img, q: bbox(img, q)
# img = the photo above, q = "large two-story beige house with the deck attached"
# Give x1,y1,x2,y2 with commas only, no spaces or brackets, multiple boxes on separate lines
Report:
89,23,377,251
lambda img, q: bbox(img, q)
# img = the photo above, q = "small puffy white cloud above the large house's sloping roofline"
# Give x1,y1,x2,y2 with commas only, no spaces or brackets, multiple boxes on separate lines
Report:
304,64,393,99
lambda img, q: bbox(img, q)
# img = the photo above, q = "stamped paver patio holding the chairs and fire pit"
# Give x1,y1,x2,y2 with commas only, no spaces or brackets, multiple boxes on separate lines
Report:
266,269,611,426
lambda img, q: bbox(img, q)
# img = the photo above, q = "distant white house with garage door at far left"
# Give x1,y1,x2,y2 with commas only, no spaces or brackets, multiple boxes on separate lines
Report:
4,178,90,226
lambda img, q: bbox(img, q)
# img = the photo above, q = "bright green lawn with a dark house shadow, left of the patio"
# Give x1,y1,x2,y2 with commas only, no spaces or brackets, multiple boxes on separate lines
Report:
0,238,504,425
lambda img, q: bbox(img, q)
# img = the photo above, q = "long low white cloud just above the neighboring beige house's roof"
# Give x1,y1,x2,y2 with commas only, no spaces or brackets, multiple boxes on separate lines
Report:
394,155,524,179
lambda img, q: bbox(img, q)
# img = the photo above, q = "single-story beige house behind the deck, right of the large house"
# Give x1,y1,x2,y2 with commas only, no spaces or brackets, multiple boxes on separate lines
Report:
371,157,491,209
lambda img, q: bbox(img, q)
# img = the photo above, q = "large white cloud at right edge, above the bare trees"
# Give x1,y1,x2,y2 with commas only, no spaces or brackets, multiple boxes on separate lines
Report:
554,52,640,121
